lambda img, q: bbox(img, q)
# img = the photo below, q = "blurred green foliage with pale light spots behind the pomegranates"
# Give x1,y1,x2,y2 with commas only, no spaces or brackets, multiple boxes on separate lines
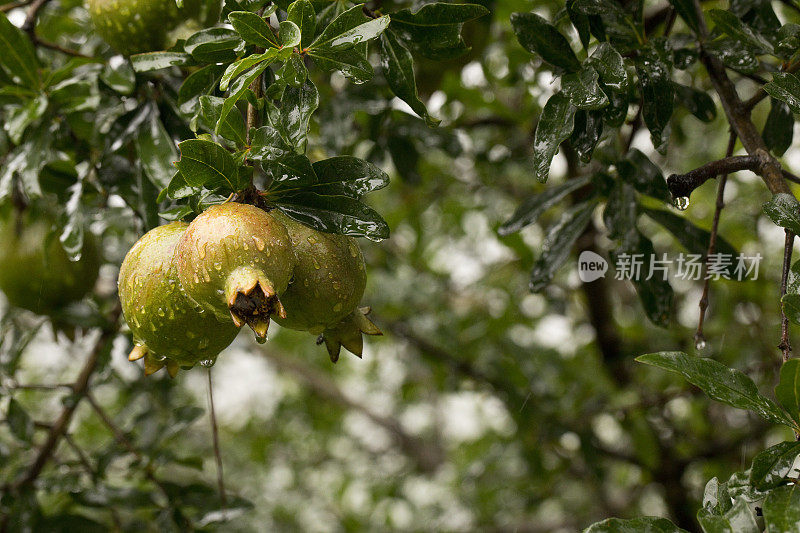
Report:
0,0,800,532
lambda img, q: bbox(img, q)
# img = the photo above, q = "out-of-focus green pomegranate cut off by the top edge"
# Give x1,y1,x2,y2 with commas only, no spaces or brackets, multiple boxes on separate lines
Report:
88,0,221,55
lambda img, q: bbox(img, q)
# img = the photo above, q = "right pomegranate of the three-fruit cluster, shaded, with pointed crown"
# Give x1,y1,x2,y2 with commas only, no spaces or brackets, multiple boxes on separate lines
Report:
275,213,381,362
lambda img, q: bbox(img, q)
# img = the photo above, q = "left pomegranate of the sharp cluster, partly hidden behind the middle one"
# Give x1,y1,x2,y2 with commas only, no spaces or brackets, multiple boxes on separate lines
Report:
118,222,239,376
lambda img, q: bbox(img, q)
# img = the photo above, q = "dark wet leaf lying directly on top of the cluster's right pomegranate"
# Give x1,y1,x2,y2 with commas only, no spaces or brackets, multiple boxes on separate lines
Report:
273,192,389,241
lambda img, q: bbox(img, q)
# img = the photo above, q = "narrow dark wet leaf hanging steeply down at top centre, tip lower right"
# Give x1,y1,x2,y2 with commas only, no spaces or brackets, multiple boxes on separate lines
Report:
381,30,441,126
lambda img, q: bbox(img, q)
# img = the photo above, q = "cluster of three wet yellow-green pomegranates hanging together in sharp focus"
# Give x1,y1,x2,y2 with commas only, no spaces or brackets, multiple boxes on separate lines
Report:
118,202,380,376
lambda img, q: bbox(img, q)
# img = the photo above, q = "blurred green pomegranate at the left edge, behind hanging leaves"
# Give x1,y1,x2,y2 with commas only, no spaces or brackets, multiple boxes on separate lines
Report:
0,206,100,314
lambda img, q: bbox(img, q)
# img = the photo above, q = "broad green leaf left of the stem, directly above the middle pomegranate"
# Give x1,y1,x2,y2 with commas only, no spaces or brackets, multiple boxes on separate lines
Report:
175,139,246,192
